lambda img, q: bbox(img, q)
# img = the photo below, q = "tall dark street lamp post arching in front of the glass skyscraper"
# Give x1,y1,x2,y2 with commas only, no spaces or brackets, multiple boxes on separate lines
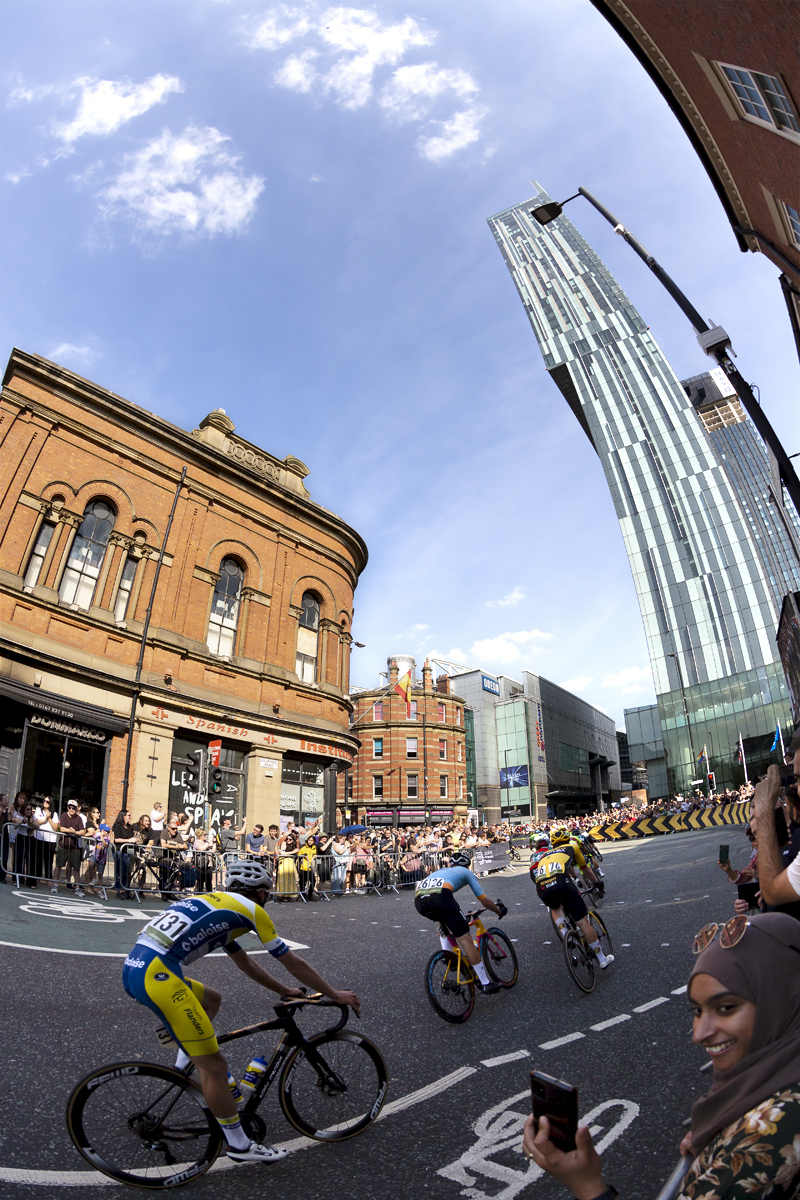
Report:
530,187,800,512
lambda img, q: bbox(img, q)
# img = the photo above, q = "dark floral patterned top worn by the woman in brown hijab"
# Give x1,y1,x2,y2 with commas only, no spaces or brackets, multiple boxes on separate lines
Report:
679,1085,800,1200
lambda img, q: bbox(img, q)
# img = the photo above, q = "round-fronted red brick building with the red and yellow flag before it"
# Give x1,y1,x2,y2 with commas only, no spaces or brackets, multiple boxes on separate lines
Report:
339,655,468,826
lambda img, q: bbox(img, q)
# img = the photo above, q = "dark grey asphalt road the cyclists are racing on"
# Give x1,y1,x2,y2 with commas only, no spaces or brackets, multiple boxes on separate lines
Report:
0,827,750,1200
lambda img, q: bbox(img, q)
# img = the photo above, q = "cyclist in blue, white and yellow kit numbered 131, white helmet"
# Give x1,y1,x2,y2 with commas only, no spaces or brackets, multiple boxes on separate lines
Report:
122,859,359,1163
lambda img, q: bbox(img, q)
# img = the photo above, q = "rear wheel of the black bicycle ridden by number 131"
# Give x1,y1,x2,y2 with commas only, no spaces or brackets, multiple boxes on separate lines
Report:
66,1062,223,1188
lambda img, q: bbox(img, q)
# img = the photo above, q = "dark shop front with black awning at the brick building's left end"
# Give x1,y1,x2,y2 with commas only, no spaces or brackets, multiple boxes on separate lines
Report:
0,679,127,814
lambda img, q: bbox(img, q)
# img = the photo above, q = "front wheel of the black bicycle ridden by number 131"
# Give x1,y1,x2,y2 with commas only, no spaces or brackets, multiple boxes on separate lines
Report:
278,1030,389,1141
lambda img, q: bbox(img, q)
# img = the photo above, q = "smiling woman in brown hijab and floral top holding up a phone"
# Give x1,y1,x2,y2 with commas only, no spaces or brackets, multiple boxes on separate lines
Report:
523,912,800,1200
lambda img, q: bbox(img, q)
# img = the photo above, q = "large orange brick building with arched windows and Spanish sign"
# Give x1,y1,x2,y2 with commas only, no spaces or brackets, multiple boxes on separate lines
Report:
0,350,367,828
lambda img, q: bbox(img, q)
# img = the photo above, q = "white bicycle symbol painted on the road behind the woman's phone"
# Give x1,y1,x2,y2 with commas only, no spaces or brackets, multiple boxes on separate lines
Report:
437,1088,639,1200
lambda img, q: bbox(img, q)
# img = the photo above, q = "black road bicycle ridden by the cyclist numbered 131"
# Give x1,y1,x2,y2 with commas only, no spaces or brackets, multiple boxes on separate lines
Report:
66,995,389,1189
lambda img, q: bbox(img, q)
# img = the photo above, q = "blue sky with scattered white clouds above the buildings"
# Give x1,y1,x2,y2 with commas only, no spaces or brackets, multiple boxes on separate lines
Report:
0,0,800,726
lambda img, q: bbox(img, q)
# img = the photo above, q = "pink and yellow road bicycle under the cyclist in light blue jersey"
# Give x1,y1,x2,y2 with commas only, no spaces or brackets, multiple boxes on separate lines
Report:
425,908,519,1025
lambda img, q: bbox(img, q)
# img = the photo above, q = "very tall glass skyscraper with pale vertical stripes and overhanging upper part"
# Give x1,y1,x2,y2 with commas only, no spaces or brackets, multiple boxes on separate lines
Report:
488,193,792,794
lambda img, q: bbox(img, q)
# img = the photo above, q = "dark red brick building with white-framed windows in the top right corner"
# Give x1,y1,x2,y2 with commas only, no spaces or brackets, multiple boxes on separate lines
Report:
591,0,800,353
